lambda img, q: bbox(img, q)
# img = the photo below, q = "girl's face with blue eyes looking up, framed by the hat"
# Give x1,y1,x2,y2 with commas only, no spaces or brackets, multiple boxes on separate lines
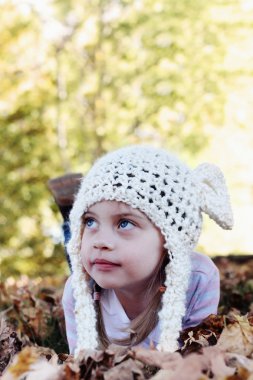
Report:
81,201,163,291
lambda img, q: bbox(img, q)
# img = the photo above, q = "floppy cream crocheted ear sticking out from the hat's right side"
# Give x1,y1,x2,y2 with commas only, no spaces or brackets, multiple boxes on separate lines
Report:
193,163,233,230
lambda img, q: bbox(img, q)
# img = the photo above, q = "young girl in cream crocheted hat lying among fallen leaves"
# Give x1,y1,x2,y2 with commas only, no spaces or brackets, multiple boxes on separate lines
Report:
63,146,233,355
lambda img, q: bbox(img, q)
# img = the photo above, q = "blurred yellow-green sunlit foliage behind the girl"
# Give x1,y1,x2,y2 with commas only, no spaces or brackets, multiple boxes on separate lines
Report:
0,0,253,280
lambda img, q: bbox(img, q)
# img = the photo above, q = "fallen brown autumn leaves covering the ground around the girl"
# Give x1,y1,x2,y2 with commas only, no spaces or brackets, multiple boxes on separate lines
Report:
0,258,253,380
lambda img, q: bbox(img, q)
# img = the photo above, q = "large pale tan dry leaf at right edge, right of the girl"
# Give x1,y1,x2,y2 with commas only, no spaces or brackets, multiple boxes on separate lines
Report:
217,315,253,356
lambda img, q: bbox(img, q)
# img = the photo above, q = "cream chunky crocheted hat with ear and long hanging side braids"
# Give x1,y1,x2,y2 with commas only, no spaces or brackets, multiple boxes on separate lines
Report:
67,145,233,355
